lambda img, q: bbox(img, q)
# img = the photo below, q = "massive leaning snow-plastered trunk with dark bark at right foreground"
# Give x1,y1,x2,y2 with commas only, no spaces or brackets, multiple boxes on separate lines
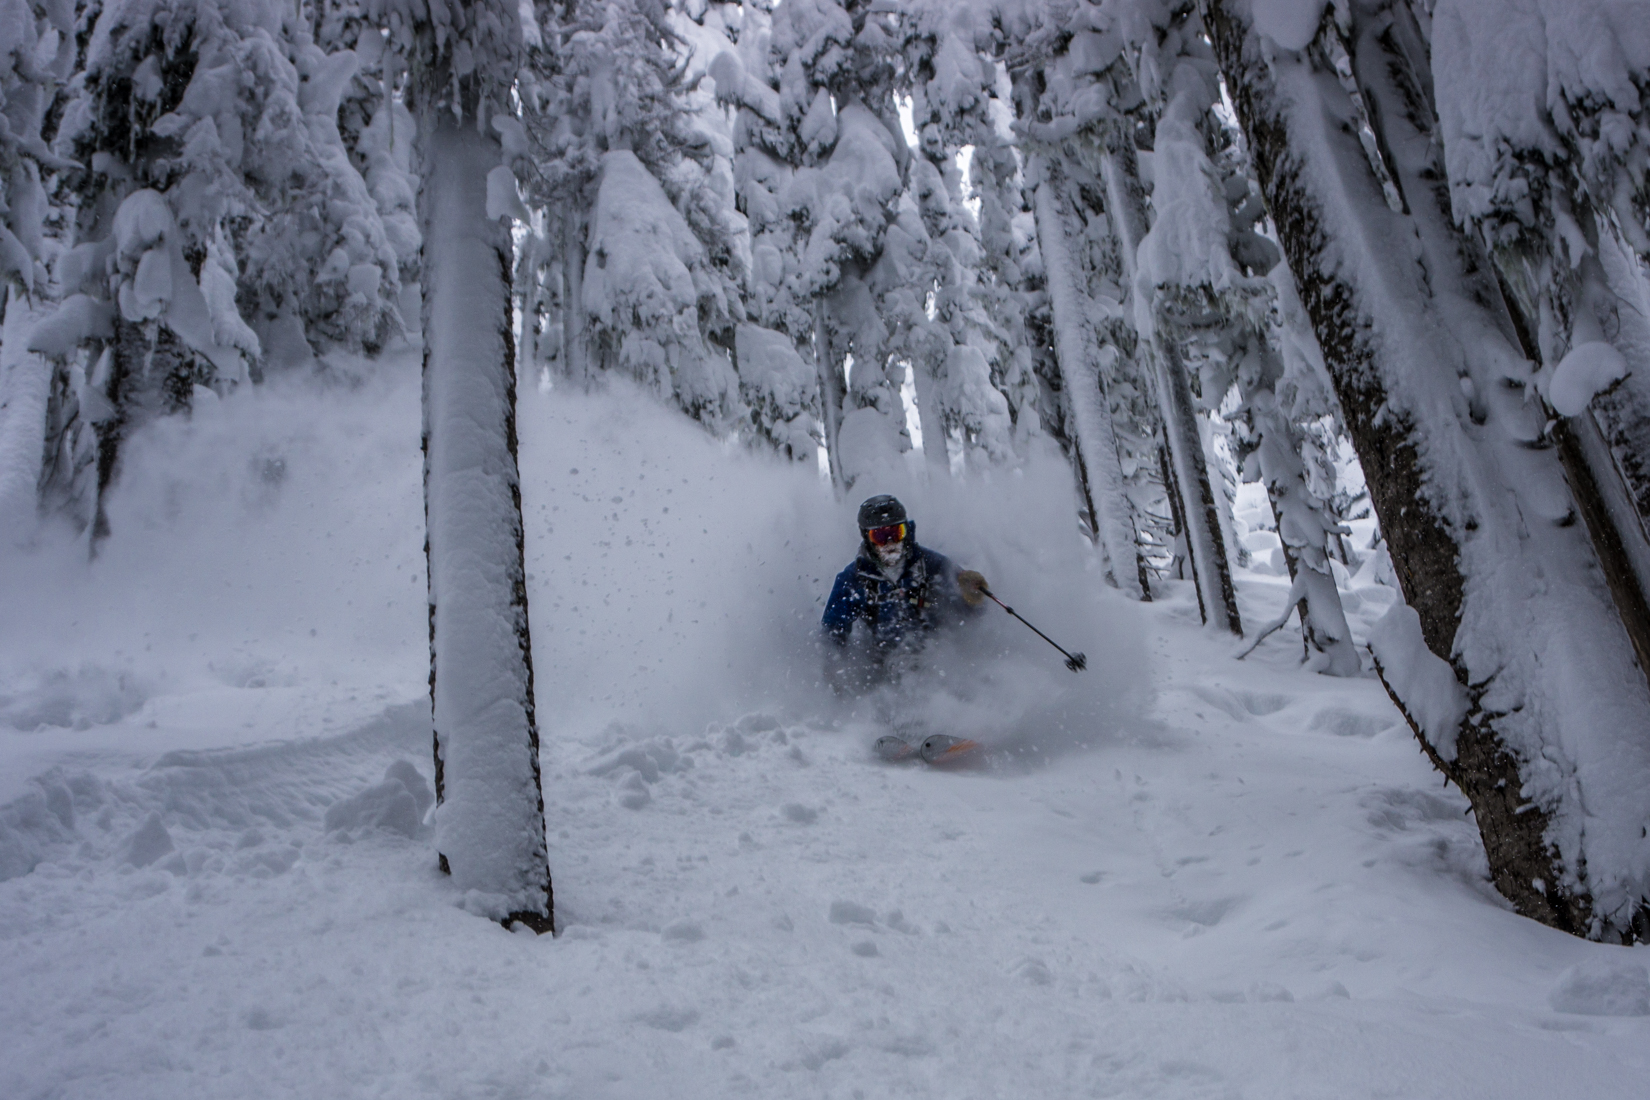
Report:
1206,0,1650,940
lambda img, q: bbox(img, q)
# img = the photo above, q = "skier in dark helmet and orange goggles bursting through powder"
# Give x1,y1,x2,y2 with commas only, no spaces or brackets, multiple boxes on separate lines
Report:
820,495,987,691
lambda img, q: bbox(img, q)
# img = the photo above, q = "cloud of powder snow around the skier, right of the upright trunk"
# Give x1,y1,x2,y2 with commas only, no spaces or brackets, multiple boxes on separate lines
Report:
521,379,1148,759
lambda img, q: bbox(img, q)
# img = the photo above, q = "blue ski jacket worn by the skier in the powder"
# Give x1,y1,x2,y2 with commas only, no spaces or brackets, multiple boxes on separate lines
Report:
820,539,978,651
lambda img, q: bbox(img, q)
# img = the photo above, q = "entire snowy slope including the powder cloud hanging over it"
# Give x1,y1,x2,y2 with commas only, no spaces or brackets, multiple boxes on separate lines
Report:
0,360,1650,1100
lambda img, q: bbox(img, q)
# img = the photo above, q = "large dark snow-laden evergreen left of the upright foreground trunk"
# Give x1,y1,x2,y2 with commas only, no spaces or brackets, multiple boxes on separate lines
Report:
31,0,399,544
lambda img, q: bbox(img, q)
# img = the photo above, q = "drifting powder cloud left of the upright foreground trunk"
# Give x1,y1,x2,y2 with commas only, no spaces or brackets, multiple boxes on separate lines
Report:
0,361,427,750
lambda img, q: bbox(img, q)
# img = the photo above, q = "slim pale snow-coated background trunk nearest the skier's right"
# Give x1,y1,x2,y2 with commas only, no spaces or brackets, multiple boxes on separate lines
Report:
1036,158,1148,600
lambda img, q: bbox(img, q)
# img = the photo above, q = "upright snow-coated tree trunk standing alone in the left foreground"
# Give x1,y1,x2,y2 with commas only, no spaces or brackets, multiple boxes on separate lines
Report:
419,109,553,932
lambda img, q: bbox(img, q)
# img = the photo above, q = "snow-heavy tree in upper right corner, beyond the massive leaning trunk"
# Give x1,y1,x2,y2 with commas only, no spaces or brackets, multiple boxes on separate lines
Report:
1412,0,1650,668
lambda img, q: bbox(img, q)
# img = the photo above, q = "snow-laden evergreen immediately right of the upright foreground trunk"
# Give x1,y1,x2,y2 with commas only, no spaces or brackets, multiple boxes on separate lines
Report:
521,0,744,432
